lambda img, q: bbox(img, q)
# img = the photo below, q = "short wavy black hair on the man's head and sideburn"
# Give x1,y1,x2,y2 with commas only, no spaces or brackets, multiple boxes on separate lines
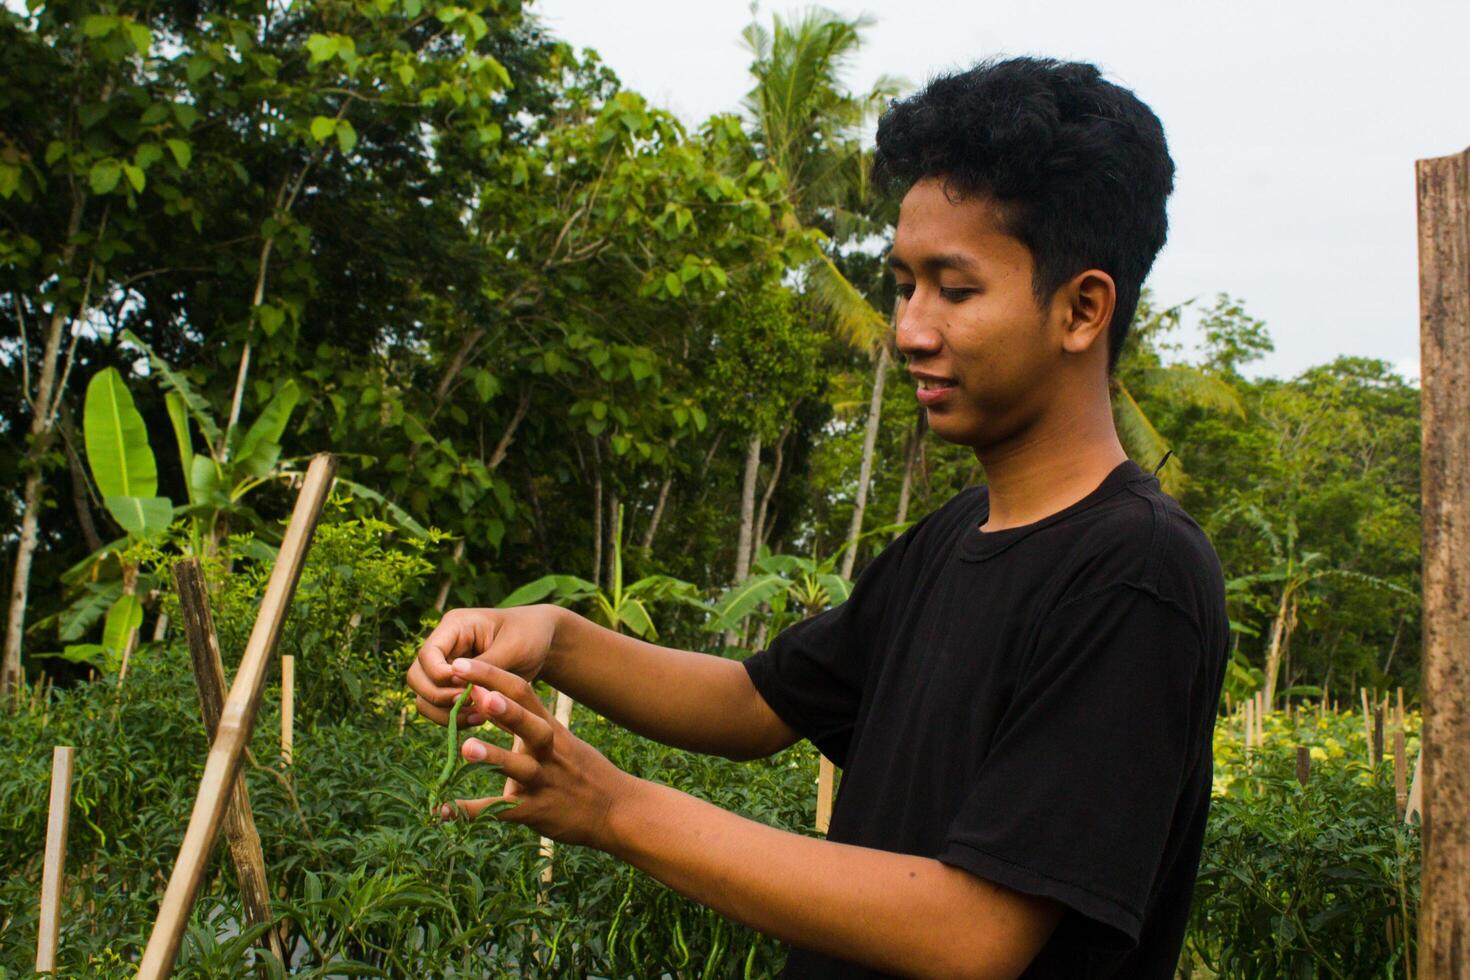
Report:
873,57,1175,373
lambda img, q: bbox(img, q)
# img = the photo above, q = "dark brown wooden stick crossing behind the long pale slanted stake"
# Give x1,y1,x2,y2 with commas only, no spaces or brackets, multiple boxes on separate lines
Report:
173,558,285,962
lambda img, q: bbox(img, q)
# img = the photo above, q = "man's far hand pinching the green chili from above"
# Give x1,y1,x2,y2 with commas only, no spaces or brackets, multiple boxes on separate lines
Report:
409,605,566,726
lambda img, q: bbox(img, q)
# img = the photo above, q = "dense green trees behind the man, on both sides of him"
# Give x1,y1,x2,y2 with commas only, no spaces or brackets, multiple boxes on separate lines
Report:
0,0,1419,705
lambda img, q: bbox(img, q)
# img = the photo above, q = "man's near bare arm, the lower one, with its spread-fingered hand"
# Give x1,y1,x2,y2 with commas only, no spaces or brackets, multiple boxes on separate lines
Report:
441,661,1063,979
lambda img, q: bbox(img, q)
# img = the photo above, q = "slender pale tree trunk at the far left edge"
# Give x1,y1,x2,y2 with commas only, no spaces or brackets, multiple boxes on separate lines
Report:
0,195,91,695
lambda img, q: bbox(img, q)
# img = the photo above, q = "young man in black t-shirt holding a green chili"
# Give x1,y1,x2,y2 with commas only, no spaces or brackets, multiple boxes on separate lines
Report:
409,59,1227,980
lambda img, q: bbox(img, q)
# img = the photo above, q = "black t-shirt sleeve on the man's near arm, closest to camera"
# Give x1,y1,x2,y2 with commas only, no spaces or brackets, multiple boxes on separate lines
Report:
939,585,1214,948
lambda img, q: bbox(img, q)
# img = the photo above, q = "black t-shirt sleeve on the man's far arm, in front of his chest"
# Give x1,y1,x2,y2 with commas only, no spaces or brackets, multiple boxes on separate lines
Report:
745,529,913,765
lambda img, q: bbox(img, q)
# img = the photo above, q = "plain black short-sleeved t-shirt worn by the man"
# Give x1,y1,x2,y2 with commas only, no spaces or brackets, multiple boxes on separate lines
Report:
745,461,1229,980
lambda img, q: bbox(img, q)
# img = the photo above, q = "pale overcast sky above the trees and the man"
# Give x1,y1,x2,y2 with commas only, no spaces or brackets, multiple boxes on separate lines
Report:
531,0,1470,378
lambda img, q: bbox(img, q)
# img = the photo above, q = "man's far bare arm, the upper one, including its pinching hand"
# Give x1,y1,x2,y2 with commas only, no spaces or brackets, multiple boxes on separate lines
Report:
409,605,800,760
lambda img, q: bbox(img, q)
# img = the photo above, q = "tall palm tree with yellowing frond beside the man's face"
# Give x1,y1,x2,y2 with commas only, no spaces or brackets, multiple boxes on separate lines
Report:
736,7,903,579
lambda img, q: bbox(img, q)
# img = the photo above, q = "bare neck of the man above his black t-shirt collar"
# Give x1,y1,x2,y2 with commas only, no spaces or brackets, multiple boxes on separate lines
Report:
976,393,1127,532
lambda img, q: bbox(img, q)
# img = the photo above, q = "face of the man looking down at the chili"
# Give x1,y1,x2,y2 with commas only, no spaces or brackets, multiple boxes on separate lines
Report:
889,179,1061,450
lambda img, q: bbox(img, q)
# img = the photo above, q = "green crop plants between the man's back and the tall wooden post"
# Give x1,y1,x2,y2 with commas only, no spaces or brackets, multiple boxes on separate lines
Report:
1185,713,1420,977
